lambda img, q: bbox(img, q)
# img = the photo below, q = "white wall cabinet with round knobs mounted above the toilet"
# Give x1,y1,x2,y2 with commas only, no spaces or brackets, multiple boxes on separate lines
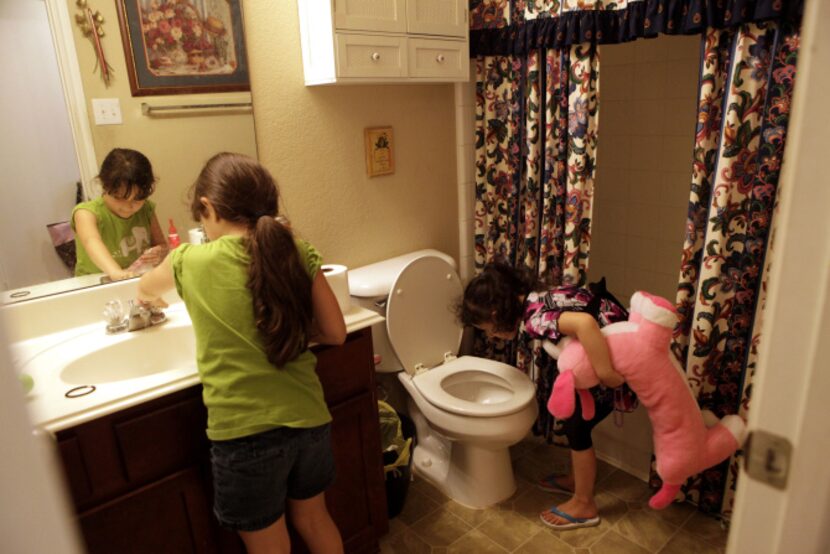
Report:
297,0,470,85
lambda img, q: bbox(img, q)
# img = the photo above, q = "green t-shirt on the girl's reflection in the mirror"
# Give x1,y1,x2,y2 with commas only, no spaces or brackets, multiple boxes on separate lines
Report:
71,197,156,277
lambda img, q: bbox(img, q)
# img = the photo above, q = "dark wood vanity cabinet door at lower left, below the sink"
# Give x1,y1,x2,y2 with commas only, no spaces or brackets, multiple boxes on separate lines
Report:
78,469,216,554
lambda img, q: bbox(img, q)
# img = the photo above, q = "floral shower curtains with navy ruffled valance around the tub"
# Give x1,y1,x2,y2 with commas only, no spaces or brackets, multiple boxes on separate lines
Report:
470,0,802,513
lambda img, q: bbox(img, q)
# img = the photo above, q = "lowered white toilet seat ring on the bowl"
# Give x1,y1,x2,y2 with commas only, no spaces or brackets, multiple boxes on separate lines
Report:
412,356,536,417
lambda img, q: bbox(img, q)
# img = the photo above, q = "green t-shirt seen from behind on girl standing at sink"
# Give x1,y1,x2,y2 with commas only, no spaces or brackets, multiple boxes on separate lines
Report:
170,235,331,441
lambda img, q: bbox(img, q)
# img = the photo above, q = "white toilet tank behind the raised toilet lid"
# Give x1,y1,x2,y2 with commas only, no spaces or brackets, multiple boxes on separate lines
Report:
348,249,457,373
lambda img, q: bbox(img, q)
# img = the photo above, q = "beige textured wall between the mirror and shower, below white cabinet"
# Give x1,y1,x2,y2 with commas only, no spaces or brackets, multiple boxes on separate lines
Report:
243,0,459,267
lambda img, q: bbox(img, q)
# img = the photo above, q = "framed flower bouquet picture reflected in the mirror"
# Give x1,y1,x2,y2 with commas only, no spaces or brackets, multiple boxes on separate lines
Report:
116,0,250,96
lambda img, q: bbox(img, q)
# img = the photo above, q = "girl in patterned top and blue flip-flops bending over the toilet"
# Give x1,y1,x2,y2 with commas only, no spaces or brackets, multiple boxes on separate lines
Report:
458,264,626,530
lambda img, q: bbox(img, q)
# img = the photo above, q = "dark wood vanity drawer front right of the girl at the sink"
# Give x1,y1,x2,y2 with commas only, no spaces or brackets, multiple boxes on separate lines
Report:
312,328,375,406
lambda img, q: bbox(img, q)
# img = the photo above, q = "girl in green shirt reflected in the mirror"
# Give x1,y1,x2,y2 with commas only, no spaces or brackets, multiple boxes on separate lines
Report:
72,148,167,280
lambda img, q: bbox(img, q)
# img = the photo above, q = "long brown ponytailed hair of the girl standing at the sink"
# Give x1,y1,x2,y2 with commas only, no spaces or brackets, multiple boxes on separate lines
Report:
190,152,312,367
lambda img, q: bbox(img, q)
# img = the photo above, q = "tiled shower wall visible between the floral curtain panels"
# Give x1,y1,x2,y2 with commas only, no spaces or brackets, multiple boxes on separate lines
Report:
589,36,700,302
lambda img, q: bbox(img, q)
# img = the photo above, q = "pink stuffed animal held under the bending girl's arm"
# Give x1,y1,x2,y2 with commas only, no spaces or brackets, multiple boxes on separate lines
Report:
545,292,746,510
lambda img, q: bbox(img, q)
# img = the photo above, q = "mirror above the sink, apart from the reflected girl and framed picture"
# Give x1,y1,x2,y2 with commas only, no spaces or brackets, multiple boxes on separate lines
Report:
0,0,256,304
